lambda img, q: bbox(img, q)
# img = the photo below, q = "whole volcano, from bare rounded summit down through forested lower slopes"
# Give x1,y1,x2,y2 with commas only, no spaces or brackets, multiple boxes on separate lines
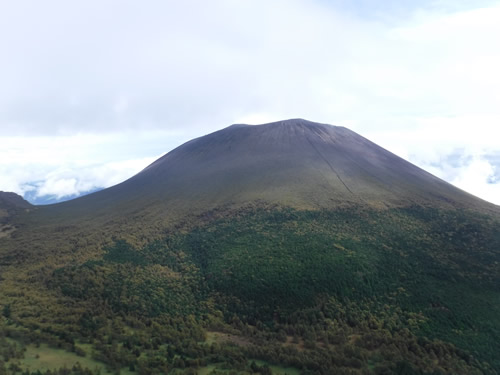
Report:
0,119,500,374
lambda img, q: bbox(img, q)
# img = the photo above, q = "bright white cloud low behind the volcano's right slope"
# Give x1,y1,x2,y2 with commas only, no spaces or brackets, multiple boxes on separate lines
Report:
366,116,500,205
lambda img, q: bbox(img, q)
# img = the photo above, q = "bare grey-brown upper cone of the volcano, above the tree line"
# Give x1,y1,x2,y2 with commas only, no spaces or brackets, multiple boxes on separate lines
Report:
40,119,497,223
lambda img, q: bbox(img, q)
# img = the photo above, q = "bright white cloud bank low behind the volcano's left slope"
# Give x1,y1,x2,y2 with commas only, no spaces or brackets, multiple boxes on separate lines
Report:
0,132,176,198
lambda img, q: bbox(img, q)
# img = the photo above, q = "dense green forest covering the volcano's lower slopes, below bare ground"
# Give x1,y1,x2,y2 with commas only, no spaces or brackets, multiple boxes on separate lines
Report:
0,206,500,374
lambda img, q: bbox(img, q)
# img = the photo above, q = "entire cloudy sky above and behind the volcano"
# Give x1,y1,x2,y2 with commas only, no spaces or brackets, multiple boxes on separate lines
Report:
0,0,500,204
